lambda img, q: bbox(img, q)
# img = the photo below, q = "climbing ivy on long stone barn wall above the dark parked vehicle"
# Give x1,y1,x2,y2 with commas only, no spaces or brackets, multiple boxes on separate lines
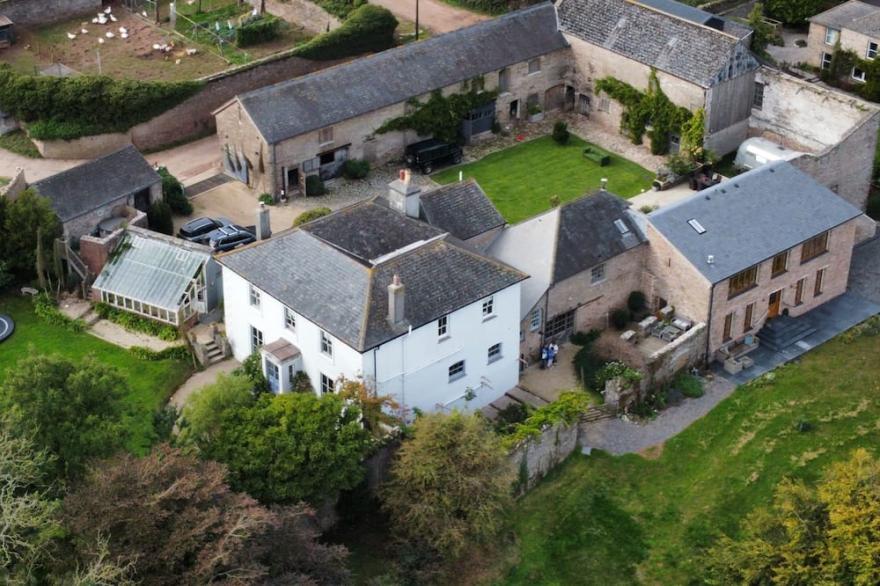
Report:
376,90,497,142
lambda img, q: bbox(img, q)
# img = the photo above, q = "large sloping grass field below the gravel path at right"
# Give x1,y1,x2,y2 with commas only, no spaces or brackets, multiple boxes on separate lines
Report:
496,326,880,585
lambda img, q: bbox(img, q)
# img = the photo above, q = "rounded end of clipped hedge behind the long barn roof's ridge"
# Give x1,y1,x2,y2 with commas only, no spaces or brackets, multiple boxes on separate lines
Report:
297,4,397,60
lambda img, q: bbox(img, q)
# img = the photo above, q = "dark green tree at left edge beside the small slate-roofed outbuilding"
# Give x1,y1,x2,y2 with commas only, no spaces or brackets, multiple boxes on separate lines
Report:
0,189,61,277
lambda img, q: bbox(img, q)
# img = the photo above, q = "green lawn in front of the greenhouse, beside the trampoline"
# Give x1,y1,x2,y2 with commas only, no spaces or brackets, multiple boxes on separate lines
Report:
0,296,192,453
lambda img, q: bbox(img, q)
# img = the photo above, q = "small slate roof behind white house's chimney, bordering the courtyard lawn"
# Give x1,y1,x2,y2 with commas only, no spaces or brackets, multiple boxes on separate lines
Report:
419,179,504,240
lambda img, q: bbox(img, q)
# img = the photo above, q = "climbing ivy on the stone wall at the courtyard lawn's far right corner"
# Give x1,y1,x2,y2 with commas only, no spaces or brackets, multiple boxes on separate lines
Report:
596,69,702,155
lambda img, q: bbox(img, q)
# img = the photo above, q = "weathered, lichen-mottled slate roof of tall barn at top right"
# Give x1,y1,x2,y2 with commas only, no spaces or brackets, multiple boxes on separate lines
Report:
558,0,758,88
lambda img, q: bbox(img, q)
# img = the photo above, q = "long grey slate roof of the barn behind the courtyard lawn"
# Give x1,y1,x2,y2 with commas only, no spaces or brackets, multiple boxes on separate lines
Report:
238,3,568,144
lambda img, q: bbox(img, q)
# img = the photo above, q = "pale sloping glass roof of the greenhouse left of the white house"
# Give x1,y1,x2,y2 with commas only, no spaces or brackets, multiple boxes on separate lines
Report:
92,230,211,311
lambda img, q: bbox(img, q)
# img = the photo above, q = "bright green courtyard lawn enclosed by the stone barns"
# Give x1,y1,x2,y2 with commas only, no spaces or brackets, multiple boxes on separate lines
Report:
433,135,654,223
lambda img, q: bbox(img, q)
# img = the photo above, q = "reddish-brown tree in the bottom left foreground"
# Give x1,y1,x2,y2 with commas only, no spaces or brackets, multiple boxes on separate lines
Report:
63,445,348,586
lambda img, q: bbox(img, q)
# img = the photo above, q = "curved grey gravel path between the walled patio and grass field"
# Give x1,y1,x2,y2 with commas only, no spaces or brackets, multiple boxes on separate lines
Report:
582,375,736,455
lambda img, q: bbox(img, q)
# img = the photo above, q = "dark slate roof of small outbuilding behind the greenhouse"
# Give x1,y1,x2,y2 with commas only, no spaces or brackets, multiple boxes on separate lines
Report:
31,146,162,222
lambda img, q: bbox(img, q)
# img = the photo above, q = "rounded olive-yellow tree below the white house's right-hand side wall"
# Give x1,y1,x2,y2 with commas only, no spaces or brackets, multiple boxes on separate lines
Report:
382,412,514,559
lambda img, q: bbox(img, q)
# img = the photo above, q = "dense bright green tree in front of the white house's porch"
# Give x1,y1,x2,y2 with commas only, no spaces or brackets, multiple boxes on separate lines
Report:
184,383,370,504
